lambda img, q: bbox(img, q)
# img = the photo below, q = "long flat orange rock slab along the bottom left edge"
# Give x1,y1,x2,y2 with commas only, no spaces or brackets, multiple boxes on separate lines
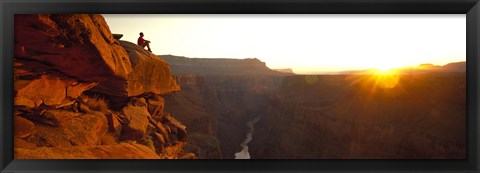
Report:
14,143,160,159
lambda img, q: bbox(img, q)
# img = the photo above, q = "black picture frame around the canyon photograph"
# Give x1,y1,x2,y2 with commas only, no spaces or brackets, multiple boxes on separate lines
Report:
0,0,480,173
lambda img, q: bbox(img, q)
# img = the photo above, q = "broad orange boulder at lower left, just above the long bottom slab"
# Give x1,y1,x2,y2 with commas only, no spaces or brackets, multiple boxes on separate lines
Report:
28,110,108,147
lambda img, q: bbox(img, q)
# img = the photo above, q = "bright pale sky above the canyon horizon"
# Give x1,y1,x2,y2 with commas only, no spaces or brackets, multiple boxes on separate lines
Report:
103,14,466,74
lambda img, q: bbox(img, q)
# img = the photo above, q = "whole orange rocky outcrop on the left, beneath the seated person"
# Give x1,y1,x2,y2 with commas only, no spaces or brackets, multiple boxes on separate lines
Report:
14,15,195,159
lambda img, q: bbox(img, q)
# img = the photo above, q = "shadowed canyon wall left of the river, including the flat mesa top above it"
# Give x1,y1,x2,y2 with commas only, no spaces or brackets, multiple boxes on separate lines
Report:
160,55,286,159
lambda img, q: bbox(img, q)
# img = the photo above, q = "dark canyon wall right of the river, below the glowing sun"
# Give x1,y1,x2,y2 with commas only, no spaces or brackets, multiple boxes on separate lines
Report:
249,72,466,159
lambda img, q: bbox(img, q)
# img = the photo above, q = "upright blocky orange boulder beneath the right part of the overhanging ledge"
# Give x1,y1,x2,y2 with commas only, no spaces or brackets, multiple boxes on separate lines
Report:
121,105,150,140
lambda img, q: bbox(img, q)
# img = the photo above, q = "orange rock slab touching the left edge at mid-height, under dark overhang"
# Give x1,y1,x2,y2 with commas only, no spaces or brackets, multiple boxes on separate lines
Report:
14,75,97,108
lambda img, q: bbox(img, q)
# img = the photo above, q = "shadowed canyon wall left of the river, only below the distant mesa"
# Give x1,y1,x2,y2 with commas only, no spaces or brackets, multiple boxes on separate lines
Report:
165,75,281,159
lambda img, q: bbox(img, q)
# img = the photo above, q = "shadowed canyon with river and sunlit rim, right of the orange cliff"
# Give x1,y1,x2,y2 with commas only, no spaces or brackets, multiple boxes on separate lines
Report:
164,55,466,159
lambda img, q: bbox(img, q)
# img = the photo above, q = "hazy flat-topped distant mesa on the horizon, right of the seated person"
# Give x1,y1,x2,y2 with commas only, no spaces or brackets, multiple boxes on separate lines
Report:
159,55,289,76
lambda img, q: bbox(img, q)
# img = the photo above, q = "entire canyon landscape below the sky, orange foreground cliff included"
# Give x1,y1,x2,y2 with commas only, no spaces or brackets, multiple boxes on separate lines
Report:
14,15,467,159
